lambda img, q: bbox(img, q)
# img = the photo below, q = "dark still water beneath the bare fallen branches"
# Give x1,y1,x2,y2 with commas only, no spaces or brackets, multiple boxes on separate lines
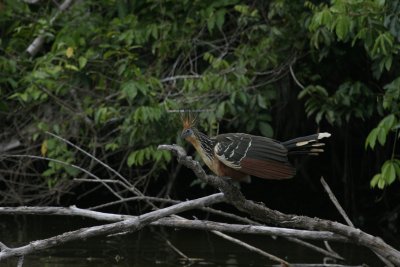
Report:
0,216,383,267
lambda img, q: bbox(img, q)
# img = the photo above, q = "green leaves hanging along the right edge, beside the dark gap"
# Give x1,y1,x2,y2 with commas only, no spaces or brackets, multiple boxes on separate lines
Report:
306,0,400,189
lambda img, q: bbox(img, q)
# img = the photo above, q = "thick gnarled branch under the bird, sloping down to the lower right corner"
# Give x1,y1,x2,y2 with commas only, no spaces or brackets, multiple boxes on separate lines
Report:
158,145,400,266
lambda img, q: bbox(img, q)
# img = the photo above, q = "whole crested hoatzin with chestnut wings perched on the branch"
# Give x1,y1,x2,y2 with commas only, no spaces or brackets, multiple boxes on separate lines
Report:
181,118,331,182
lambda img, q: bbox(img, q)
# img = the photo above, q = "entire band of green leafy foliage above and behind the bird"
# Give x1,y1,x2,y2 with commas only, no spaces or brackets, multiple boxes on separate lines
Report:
0,0,400,197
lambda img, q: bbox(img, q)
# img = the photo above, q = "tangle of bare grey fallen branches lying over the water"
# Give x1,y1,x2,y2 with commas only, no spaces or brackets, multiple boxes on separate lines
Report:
0,142,400,266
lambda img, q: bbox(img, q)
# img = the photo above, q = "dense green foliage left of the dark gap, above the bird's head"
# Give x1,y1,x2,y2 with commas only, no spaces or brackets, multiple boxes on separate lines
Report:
0,0,306,195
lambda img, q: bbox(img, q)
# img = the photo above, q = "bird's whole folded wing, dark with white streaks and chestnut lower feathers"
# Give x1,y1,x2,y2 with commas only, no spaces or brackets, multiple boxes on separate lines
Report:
214,133,296,179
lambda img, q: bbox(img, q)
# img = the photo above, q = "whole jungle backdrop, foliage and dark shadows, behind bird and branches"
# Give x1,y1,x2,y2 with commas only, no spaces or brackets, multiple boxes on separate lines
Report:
0,0,400,264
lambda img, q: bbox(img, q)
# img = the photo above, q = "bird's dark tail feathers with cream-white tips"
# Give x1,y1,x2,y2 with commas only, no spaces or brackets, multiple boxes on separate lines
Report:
282,133,331,155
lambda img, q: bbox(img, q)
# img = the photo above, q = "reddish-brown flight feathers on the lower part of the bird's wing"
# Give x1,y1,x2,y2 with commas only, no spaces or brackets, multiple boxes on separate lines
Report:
240,157,296,179
